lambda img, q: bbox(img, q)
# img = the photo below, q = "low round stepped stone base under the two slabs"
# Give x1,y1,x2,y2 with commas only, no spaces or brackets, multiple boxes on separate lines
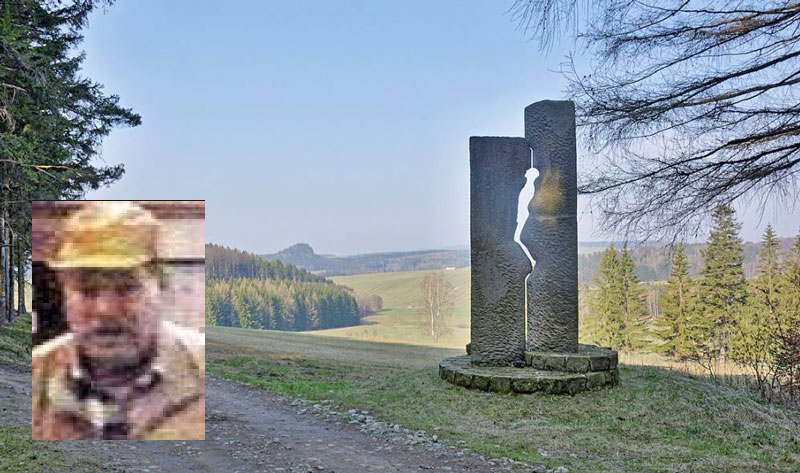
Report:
439,345,619,394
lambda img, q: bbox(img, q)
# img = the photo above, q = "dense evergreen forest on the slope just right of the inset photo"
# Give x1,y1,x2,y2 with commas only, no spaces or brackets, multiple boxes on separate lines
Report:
206,245,360,330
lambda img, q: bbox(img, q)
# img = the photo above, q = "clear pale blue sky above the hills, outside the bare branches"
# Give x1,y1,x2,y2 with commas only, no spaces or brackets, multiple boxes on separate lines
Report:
83,0,800,255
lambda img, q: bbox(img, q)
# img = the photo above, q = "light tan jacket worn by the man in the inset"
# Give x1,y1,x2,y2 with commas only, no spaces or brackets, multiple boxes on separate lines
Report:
33,322,205,440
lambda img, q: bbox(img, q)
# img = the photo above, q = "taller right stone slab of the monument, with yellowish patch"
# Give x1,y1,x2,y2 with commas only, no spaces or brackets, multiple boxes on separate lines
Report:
521,100,578,353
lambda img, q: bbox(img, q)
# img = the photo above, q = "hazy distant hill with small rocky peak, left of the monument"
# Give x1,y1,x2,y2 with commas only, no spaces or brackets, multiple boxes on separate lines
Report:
261,243,469,276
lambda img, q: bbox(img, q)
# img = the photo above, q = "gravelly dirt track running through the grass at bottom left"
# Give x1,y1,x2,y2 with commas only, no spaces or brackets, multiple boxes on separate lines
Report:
0,365,520,473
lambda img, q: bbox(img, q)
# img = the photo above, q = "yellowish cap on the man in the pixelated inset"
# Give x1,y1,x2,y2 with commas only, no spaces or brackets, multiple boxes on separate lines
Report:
48,201,158,269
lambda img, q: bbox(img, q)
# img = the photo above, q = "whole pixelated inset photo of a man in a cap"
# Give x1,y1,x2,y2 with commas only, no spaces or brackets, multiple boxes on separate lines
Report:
32,201,205,440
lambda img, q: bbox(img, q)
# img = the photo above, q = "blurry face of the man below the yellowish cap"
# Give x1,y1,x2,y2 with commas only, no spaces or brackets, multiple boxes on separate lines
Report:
60,267,158,365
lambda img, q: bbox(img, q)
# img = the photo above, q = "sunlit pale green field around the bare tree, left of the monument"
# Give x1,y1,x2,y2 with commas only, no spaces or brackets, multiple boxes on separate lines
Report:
308,268,469,349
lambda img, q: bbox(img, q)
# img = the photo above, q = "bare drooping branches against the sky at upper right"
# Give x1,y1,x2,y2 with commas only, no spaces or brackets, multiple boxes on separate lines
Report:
511,0,800,238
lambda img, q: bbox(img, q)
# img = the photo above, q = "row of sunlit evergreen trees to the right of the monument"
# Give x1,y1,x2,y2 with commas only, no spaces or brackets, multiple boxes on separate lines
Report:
588,206,800,402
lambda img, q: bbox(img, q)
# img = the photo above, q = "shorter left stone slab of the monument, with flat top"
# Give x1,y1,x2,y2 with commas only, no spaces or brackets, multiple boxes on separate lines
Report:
469,137,531,366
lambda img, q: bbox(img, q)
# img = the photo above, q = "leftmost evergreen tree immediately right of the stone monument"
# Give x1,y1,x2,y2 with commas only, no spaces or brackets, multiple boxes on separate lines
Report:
589,245,625,349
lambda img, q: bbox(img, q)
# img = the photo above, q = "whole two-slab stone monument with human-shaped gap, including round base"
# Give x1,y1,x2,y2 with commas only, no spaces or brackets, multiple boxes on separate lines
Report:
439,100,619,394
